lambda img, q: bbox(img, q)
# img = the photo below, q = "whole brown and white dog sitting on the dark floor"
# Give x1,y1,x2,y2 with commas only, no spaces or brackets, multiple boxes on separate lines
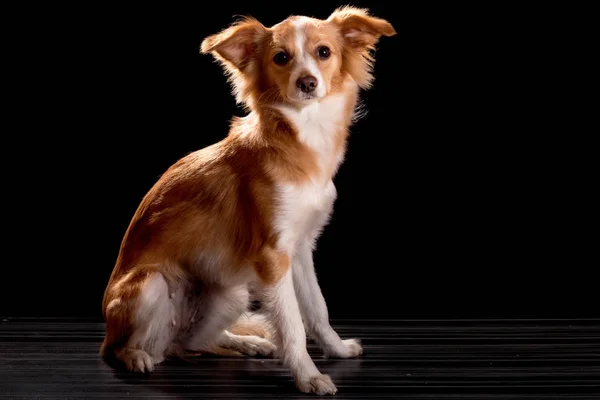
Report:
102,7,396,394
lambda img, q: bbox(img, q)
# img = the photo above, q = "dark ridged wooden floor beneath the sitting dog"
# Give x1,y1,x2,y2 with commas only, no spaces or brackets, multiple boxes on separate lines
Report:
0,318,600,400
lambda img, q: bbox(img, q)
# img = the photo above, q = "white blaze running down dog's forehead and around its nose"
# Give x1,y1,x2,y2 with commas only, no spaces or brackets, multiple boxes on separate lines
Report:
289,17,326,98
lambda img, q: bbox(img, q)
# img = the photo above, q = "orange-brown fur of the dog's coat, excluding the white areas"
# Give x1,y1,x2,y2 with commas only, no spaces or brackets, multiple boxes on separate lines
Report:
102,8,395,378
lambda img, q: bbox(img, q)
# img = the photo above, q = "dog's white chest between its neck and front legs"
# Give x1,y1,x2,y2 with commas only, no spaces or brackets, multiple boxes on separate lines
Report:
274,180,337,254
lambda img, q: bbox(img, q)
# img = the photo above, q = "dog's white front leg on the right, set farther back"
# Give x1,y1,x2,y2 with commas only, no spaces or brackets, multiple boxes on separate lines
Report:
292,242,362,358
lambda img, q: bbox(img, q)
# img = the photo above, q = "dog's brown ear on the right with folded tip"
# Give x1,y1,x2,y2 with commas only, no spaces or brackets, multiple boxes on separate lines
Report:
328,6,396,51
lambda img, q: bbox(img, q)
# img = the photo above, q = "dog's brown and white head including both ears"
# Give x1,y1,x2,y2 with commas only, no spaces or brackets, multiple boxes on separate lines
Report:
201,7,396,105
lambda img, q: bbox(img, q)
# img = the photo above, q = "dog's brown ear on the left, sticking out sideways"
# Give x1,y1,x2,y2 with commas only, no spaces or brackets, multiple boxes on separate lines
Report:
200,17,267,72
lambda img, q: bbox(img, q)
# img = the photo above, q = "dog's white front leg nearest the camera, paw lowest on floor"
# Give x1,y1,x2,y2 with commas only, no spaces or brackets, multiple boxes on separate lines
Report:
259,252,337,395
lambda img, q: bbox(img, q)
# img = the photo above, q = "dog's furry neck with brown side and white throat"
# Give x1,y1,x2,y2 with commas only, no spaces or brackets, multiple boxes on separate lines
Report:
230,80,358,183
